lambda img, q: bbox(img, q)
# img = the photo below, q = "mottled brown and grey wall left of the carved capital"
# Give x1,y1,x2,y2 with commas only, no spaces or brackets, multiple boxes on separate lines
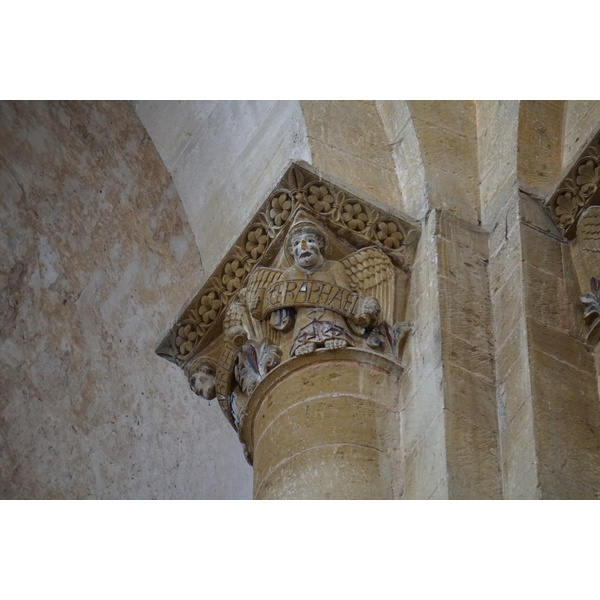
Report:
0,102,252,499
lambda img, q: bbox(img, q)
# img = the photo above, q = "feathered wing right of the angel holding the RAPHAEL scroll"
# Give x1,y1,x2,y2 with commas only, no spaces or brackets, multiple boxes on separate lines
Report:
340,246,395,323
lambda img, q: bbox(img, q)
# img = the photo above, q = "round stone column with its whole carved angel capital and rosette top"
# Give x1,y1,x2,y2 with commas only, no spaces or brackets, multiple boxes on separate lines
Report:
157,165,420,499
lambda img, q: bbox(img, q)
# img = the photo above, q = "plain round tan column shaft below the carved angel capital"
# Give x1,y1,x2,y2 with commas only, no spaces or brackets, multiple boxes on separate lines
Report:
240,348,400,500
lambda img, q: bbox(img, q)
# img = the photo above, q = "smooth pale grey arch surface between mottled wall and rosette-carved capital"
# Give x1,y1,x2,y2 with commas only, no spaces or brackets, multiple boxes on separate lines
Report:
136,101,311,275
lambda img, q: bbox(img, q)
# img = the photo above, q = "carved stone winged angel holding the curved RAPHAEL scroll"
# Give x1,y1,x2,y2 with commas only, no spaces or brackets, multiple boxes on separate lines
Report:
246,220,394,357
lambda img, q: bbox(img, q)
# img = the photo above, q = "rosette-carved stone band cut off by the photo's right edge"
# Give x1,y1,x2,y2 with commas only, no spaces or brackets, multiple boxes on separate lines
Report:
545,133,600,239
